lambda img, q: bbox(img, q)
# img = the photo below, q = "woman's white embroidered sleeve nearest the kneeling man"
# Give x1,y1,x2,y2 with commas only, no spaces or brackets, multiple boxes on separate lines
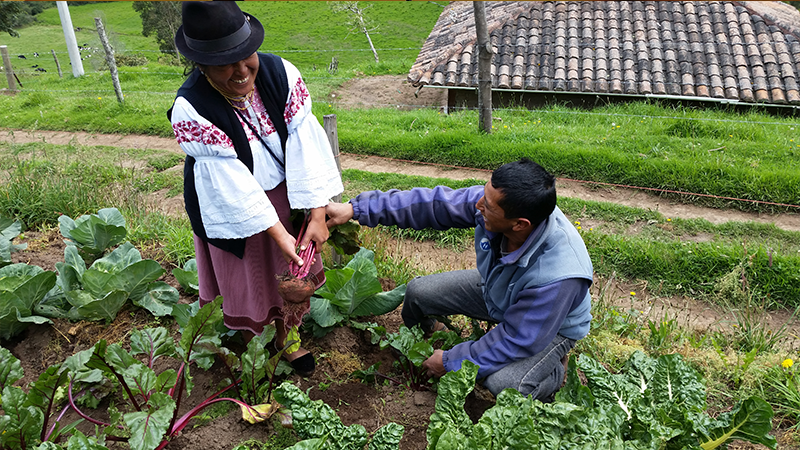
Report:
283,60,344,209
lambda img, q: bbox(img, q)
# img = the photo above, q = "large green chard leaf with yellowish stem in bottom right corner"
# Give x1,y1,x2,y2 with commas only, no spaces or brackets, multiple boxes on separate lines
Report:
694,397,777,450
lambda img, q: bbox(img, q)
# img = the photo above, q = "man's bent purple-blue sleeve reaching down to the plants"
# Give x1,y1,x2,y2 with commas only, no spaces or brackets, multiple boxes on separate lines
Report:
442,278,589,378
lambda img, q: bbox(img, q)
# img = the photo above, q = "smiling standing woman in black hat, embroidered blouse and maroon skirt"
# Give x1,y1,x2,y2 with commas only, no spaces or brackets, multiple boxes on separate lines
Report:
169,2,343,376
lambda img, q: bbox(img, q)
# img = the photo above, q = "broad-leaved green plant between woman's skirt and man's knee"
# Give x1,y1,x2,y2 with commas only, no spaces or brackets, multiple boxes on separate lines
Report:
307,248,406,337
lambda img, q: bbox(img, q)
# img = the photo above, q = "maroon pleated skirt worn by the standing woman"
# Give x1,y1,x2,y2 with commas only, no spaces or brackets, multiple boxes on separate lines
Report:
194,181,325,334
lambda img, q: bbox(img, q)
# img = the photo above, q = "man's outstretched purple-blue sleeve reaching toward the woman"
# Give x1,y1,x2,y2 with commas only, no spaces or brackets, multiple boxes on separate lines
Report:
350,186,483,230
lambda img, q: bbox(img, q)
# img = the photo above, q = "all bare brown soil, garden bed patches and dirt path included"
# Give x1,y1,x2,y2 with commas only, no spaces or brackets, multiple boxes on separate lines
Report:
0,76,800,450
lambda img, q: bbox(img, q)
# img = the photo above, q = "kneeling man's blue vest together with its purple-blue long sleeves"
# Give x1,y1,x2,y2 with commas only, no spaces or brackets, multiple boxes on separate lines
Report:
350,186,593,378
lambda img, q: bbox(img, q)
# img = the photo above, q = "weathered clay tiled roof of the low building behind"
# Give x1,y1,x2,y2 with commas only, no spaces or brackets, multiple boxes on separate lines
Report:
408,1,800,104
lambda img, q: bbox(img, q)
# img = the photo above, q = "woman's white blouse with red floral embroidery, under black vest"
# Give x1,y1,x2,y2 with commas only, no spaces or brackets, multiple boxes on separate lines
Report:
172,60,344,239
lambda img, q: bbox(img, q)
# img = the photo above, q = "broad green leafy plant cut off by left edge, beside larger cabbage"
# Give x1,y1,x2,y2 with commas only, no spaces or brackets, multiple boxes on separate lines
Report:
0,263,56,339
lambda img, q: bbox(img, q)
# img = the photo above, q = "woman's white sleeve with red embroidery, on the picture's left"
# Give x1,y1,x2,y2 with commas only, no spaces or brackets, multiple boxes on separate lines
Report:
172,97,278,239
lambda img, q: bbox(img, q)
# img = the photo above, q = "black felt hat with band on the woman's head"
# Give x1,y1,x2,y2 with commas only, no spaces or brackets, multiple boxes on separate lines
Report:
175,1,264,66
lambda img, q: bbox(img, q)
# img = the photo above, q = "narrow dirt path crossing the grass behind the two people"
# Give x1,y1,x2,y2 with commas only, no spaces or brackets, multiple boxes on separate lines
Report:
0,129,800,231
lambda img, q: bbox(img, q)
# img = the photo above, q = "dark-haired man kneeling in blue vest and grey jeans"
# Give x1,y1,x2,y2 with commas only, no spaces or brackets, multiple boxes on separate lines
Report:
326,158,593,400
